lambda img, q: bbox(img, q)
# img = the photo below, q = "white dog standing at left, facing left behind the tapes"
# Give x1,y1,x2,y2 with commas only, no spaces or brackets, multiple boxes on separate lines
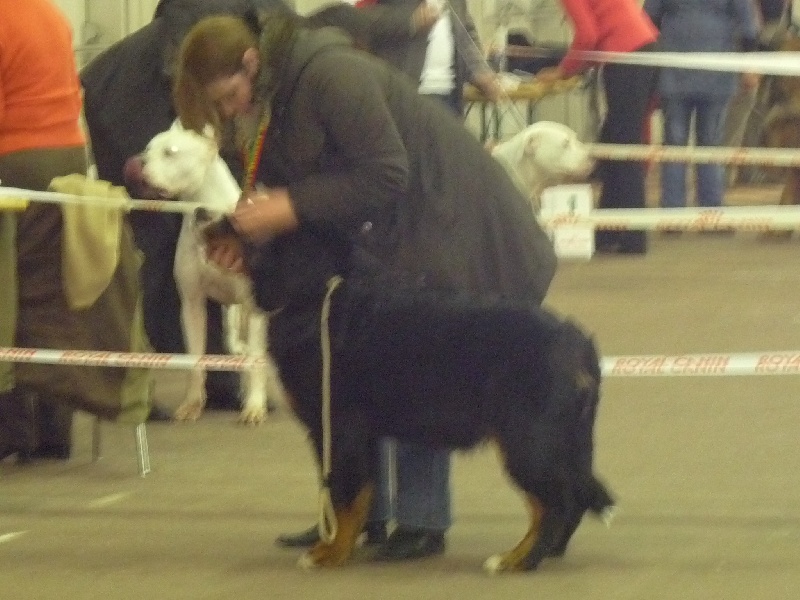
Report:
126,121,284,423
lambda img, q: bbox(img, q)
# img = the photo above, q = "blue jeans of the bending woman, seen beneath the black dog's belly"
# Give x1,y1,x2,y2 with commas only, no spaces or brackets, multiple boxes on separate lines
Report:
369,439,452,531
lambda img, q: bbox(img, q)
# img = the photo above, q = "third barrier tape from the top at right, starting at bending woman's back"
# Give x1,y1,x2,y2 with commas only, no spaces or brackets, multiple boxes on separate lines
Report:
539,206,800,232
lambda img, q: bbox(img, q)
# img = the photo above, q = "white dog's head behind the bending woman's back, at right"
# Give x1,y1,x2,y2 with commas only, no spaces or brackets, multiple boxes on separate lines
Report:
492,121,594,210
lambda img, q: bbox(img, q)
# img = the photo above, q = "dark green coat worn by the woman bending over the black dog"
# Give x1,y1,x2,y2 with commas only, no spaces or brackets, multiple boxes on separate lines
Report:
250,22,556,308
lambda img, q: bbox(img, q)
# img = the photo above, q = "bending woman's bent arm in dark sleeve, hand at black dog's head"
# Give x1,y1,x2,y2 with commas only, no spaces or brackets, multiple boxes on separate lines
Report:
219,52,409,246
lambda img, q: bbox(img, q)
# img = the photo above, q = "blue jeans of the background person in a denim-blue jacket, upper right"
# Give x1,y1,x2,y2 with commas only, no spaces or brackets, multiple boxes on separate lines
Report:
661,96,728,208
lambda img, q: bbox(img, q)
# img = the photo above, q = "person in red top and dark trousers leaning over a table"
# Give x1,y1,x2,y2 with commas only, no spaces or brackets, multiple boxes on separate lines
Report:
537,0,658,254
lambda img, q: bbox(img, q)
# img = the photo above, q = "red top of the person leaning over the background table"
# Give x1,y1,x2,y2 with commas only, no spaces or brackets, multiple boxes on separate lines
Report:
560,0,658,75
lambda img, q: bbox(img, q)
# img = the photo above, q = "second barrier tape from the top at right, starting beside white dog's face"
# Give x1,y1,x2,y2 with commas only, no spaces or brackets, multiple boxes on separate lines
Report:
587,144,800,167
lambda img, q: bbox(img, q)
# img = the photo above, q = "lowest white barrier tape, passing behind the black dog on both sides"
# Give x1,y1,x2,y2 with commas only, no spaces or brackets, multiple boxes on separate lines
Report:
0,348,800,377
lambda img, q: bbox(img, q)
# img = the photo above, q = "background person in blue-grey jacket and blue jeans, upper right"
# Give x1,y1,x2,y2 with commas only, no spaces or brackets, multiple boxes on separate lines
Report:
644,0,759,216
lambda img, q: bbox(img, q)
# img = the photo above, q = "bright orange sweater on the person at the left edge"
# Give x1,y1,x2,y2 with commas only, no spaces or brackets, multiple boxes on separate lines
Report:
0,0,85,156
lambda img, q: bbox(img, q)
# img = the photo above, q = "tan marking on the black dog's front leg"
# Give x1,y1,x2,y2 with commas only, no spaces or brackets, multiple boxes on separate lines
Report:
299,484,374,568
